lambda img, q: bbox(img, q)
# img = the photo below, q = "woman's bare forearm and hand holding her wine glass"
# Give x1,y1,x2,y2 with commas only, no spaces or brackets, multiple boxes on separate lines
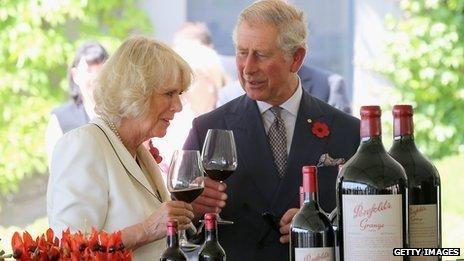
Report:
121,201,194,249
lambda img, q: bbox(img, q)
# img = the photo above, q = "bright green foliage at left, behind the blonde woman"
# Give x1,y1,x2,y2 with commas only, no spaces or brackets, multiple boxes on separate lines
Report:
0,0,151,195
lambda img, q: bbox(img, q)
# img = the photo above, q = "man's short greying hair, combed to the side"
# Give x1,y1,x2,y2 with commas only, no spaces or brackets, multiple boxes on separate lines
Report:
232,0,308,57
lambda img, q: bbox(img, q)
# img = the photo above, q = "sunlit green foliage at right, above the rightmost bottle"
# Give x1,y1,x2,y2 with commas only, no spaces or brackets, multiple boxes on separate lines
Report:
384,0,464,159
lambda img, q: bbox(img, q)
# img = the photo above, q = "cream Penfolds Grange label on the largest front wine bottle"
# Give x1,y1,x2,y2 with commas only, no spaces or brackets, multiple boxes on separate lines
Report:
342,194,403,261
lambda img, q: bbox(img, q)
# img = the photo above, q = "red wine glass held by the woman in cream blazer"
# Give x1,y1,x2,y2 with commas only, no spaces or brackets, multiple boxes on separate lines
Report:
167,150,204,250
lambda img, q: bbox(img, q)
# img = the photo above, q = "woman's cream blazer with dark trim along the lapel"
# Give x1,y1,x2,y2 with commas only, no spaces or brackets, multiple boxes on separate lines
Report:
47,119,169,260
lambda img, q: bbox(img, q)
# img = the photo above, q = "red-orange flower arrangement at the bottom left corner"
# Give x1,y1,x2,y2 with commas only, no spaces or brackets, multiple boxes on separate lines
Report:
11,228,132,261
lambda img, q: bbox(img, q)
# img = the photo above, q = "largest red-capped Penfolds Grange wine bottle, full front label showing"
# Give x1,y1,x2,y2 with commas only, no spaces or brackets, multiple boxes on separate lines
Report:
337,106,408,260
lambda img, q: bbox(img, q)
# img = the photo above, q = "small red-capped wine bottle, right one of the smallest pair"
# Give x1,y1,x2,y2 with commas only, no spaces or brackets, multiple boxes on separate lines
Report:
198,213,226,261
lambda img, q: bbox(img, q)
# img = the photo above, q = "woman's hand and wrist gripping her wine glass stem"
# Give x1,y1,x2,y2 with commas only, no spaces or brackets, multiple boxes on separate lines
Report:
142,201,194,242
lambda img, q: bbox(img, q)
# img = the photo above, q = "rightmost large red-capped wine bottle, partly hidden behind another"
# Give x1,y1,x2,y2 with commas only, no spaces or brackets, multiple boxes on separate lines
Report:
389,105,441,260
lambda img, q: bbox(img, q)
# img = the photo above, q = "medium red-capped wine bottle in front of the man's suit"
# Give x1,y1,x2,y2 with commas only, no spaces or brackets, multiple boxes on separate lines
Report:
289,166,335,261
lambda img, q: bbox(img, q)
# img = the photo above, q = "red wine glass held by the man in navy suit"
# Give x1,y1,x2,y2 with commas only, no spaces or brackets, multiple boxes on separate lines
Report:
201,129,237,224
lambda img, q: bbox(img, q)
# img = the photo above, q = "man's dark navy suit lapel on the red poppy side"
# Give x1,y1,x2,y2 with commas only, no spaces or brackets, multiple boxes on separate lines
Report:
272,92,331,215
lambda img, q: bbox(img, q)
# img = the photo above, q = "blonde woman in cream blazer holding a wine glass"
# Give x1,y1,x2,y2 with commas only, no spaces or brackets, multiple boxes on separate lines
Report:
47,36,194,260
